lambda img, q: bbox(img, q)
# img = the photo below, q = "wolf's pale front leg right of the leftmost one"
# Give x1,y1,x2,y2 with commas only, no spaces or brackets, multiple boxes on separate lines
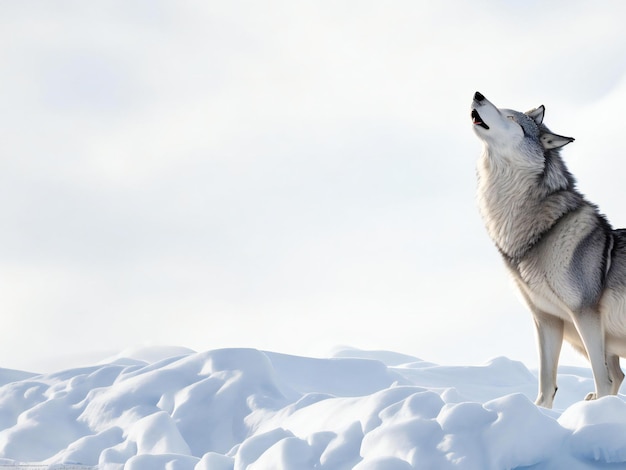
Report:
574,310,614,400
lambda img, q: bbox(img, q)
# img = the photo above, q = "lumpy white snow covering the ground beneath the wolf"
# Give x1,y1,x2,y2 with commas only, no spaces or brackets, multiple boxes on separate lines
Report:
0,347,626,470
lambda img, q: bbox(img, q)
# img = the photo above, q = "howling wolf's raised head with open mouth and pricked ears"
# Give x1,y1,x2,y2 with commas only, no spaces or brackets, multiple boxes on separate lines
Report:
471,92,574,162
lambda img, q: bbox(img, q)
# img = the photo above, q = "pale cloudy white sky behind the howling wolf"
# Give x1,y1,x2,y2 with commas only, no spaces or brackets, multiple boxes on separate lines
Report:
0,0,626,370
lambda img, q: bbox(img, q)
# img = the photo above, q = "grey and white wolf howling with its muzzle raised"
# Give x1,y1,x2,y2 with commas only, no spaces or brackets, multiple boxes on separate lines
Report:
471,92,626,408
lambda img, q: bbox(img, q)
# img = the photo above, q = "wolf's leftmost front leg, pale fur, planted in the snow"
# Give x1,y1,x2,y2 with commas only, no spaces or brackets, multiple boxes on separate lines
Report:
533,312,564,408
